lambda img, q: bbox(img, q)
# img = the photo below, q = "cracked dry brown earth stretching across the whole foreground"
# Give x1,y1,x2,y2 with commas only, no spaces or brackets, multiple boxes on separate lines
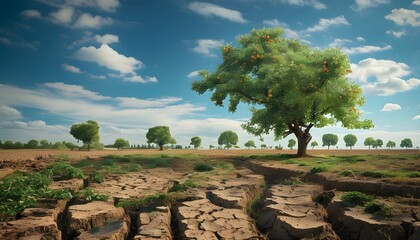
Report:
0,158,420,240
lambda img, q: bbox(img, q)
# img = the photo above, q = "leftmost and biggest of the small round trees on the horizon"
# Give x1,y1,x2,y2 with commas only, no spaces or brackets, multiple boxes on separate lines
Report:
70,120,99,151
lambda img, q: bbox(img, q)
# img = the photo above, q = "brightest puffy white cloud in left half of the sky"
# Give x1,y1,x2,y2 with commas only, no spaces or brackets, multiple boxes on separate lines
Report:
74,44,144,74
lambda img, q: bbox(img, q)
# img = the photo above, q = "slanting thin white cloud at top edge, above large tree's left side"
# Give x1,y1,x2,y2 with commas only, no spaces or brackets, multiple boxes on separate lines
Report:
187,2,247,23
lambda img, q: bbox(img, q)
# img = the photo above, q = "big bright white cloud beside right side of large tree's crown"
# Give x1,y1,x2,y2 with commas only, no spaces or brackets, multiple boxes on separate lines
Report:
348,58,420,96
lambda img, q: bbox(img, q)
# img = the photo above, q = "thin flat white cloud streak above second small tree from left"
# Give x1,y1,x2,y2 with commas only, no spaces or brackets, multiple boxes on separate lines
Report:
115,97,182,108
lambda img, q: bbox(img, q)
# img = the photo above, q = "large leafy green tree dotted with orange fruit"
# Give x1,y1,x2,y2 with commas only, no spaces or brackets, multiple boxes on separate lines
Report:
192,28,373,156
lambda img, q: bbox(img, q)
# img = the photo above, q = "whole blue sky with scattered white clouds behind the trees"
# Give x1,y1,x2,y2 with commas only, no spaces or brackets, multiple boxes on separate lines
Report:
0,0,420,148
